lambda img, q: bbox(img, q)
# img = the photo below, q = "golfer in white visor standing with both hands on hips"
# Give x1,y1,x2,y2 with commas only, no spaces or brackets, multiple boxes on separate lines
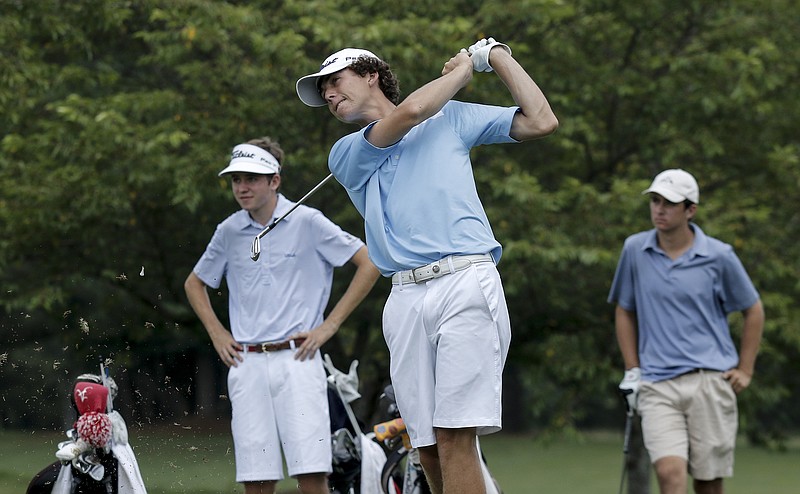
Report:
184,137,379,494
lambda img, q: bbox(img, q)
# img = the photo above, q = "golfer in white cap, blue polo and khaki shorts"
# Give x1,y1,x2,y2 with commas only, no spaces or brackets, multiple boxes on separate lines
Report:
608,169,764,494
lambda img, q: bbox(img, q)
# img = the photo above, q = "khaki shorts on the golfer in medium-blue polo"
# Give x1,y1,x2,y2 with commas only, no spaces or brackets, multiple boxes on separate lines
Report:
638,370,738,480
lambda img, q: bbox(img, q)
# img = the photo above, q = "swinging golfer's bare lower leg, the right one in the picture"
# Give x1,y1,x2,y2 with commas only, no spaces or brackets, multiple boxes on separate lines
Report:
436,427,486,494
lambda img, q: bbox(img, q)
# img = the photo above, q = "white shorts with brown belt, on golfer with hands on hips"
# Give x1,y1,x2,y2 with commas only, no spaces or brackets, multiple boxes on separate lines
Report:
228,350,331,482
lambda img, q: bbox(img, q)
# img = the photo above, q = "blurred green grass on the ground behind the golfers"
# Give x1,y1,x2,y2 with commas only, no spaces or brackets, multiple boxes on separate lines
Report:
0,426,800,494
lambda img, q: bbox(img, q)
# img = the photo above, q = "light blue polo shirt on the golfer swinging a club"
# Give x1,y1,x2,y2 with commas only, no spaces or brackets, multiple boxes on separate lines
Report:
328,101,518,276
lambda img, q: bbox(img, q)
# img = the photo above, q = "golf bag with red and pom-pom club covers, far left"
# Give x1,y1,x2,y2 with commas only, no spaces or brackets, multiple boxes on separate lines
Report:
26,365,147,494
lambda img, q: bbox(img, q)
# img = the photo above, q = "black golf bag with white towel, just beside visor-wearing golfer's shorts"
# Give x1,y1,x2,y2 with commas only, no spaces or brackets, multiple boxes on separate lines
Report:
324,355,386,494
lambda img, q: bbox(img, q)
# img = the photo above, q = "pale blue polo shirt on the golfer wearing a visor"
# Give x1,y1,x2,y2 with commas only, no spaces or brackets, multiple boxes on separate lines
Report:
194,194,364,343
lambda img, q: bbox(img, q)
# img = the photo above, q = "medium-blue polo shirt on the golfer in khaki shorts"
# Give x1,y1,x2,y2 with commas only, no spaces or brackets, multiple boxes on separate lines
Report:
608,224,759,381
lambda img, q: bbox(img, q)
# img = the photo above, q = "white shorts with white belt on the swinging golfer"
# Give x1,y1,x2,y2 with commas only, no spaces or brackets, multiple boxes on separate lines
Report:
383,262,511,447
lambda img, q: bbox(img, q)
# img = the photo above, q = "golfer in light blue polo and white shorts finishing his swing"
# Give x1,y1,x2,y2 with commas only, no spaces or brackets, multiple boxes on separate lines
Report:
296,38,558,494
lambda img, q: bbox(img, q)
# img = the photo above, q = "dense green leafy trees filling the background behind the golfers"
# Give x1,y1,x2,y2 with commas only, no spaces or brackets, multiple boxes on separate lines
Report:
0,0,800,444
